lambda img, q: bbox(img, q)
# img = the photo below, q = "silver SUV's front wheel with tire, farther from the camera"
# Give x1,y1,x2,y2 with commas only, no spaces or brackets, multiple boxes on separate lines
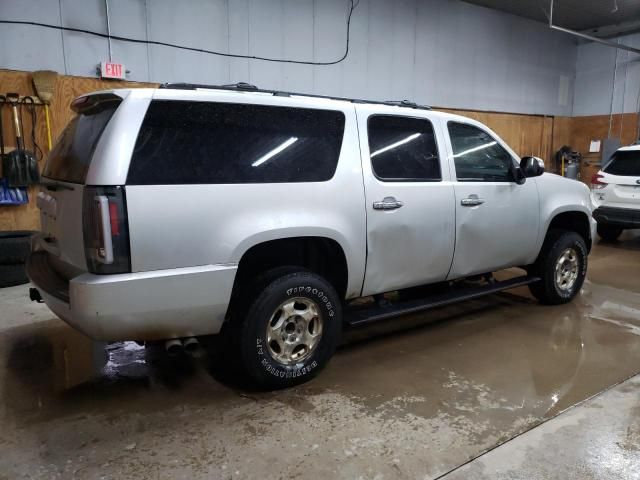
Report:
529,230,587,305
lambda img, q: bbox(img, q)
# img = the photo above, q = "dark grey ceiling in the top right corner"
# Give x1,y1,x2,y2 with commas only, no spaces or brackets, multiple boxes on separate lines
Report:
465,0,640,37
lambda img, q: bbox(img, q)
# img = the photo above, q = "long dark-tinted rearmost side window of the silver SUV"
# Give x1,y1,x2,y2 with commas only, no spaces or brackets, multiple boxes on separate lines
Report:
127,100,345,185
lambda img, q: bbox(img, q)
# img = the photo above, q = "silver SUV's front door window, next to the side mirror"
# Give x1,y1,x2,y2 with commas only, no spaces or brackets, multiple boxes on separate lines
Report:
448,122,513,182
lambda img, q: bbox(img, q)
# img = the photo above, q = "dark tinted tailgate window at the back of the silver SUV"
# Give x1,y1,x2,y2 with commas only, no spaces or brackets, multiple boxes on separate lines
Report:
43,95,122,183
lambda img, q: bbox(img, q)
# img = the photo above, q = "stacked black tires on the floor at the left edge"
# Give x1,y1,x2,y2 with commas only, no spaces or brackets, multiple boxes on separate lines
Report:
0,230,35,288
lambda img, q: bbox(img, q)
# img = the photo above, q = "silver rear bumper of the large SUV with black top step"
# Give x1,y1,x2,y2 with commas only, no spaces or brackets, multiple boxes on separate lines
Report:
27,252,237,341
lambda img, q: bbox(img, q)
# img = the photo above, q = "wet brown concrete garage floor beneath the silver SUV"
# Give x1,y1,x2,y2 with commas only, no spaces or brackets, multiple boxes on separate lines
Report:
0,233,640,479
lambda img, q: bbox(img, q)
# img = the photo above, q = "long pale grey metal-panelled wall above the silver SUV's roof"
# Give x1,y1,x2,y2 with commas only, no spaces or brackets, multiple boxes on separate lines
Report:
0,0,577,115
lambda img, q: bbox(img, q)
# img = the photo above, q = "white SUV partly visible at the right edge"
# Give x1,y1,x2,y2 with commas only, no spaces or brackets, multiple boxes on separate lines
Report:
591,145,640,241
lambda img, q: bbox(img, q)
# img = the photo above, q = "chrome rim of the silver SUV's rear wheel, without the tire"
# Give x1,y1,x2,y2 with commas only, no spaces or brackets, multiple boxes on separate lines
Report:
267,297,324,365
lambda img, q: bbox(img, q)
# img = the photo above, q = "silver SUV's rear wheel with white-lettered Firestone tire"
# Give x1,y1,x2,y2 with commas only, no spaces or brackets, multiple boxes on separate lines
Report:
234,269,342,389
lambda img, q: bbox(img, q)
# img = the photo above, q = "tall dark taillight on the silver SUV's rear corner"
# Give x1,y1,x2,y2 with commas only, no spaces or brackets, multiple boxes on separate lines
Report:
82,187,131,274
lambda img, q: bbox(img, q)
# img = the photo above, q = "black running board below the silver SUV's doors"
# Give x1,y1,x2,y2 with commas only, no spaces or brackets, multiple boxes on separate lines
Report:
344,275,540,327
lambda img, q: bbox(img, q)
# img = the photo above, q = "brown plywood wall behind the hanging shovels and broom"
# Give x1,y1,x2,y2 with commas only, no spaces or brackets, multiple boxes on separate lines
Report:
0,70,155,231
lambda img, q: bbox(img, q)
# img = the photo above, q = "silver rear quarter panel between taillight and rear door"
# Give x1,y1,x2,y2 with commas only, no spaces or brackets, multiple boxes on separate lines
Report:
126,98,366,296
